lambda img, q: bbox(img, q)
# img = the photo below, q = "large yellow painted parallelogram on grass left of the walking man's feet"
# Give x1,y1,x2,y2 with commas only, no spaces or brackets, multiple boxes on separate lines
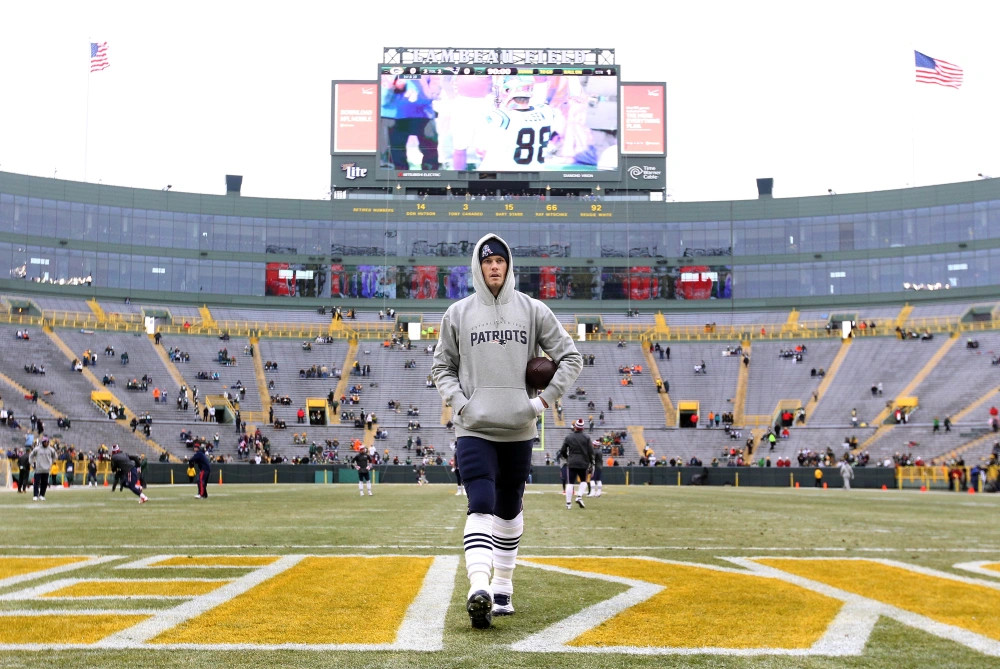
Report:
150,557,433,644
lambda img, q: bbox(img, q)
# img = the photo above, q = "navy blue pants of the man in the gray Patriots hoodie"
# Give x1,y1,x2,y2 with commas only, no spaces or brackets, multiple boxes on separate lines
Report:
455,437,532,520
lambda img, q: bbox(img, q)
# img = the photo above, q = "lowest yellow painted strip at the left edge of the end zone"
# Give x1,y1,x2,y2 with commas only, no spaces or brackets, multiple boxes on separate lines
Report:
0,614,149,652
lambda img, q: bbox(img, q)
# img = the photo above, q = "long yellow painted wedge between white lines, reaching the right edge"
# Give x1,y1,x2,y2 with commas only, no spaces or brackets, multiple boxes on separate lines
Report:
755,558,1000,640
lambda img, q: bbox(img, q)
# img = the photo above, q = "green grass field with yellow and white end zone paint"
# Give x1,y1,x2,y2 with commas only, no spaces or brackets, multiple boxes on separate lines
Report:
0,484,1000,669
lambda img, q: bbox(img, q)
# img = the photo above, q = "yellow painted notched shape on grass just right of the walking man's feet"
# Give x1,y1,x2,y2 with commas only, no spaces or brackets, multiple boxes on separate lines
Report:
525,558,842,649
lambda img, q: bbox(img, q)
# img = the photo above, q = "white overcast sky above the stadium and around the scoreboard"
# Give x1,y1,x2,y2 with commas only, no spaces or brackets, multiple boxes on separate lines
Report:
0,0,1000,201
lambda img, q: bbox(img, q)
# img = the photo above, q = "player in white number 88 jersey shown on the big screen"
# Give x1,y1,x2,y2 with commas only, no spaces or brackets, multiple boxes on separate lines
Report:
479,75,558,172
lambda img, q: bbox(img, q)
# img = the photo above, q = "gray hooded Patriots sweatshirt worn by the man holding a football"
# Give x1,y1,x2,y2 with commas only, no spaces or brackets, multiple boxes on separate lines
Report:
431,233,583,441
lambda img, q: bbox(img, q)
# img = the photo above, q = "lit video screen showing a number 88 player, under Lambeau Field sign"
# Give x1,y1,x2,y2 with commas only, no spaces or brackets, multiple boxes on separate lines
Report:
378,65,619,177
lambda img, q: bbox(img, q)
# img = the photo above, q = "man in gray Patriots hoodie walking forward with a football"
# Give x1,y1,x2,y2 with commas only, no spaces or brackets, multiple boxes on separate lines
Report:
431,234,583,629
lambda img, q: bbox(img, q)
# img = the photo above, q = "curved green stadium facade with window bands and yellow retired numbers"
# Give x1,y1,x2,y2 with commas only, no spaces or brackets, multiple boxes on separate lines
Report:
0,173,1000,313
